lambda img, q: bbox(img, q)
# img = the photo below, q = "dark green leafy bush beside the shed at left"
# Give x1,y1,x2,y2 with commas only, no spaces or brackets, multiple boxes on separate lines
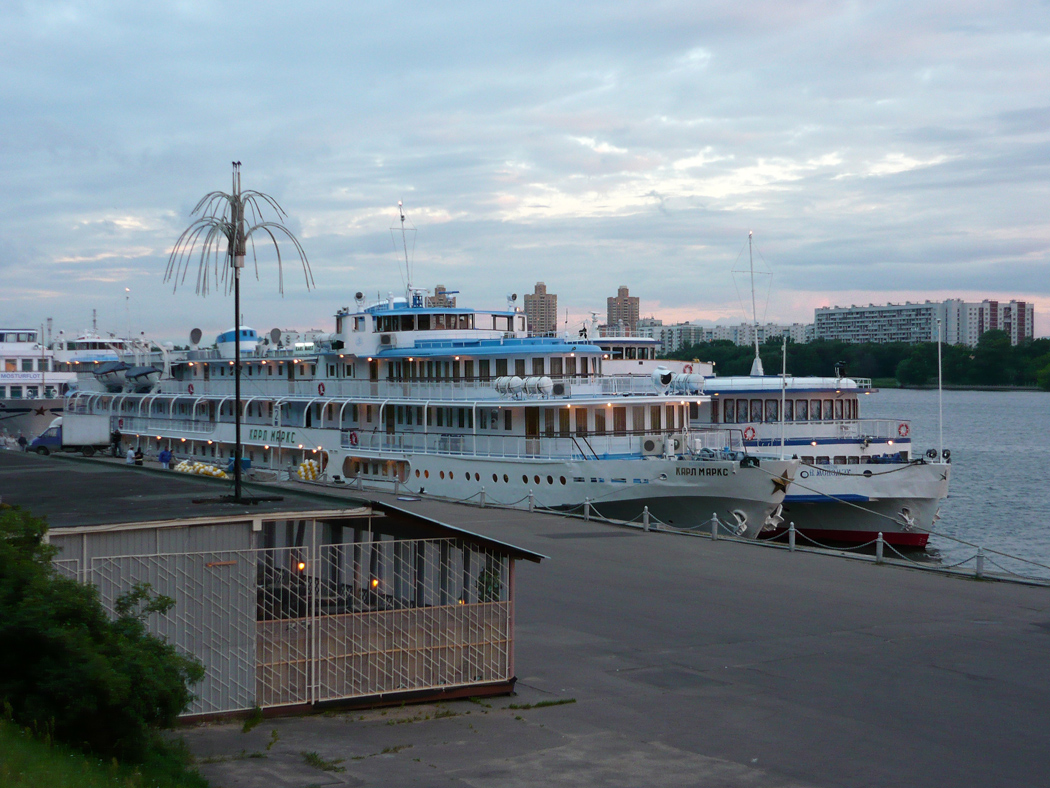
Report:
0,509,204,761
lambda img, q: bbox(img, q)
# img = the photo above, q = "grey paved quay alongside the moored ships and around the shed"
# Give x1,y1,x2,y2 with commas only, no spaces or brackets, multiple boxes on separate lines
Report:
0,458,1050,788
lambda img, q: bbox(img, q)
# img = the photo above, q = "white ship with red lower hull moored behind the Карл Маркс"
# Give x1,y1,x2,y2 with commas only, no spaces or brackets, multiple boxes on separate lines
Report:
594,336,951,547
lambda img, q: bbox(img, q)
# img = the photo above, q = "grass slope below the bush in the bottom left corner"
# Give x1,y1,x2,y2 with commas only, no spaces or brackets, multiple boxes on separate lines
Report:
0,720,208,788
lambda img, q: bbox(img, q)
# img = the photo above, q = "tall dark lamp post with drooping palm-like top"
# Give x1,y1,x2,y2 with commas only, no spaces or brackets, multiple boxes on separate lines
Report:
164,162,314,503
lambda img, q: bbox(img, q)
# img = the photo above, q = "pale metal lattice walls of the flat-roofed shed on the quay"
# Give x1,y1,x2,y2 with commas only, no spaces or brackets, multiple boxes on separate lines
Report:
84,539,512,714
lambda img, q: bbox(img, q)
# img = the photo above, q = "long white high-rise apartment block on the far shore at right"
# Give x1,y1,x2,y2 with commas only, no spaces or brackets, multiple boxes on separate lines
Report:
814,298,1034,347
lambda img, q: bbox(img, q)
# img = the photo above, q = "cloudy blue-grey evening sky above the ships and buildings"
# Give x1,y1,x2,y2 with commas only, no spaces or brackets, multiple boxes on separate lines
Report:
0,0,1050,343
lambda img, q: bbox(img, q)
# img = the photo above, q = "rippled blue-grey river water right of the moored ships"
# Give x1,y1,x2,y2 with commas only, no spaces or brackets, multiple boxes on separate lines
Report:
861,389,1050,578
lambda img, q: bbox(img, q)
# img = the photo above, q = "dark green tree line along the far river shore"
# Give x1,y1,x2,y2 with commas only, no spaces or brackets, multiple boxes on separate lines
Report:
669,331,1050,391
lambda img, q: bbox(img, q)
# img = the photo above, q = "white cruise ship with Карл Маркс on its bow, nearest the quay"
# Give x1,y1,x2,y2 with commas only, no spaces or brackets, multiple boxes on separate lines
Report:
67,287,798,537
